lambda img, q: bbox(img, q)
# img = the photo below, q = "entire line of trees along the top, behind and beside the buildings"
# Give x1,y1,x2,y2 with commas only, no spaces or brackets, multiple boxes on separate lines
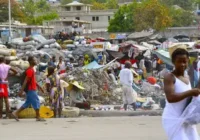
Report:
0,0,200,32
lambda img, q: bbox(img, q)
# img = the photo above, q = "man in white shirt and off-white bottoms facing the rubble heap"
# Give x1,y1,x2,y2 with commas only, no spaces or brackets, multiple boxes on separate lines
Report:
119,61,137,110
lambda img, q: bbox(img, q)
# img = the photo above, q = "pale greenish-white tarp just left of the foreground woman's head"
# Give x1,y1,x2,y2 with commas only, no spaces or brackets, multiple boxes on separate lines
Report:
153,50,173,66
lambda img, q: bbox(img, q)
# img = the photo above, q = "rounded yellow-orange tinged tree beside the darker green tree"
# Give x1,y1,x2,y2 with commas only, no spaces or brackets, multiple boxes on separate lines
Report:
134,0,172,31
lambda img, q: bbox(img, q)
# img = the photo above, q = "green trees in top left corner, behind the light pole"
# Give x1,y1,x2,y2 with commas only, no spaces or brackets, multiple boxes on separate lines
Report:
0,0,58,25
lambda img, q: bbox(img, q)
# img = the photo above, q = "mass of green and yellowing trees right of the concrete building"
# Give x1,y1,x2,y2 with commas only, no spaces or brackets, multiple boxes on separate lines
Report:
108,0,197,32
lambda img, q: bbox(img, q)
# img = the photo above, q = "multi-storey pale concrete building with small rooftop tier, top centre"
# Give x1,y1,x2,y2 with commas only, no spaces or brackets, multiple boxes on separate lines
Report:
45,1,117,33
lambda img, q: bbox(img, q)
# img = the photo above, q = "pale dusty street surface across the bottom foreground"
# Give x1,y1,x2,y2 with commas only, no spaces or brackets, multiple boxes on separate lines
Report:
0,116,184,140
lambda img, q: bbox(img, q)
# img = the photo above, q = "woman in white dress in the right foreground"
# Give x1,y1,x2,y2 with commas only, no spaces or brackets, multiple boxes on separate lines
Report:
162,47,200,140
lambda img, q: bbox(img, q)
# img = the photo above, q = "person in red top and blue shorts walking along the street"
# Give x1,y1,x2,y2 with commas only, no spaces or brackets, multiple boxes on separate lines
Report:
12,56,45,121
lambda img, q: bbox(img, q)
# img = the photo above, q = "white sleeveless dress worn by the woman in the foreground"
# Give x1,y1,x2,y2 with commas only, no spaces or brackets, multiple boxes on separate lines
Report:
162,77,199,140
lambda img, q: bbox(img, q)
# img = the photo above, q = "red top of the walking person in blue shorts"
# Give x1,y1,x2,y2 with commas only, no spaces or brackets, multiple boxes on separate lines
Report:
26,68,37,90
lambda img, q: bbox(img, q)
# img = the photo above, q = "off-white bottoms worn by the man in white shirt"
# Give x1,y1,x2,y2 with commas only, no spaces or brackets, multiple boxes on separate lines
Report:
122,85,137,105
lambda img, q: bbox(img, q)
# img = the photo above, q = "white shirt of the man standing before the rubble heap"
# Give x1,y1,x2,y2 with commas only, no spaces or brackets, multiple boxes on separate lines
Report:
119,68,133,86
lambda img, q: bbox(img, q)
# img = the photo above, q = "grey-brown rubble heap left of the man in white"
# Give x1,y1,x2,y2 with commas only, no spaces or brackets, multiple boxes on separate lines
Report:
65,68,122,105
